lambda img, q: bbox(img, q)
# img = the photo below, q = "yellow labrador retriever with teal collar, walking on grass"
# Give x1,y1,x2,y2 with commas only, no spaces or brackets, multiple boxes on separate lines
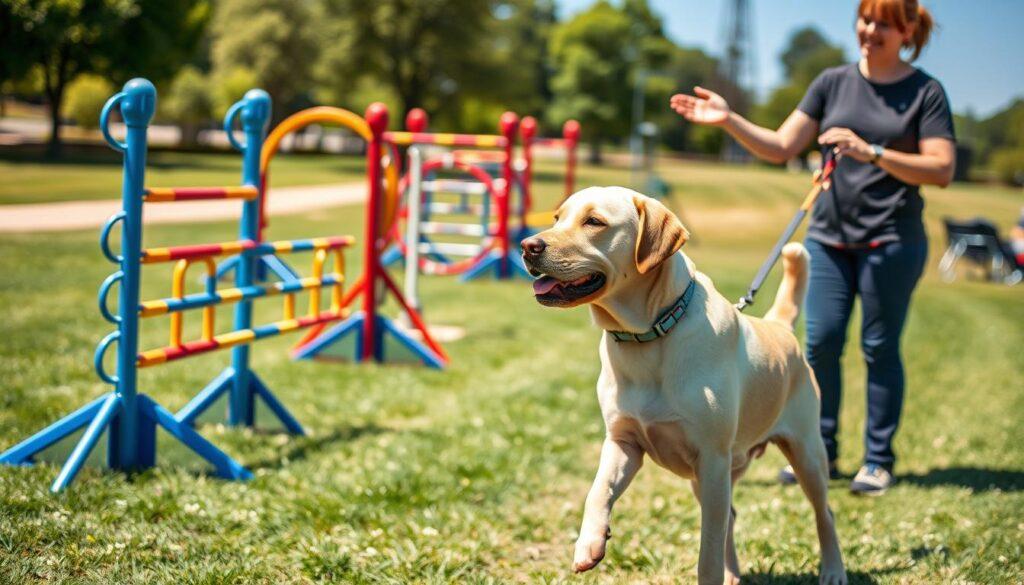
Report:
522,187,846,585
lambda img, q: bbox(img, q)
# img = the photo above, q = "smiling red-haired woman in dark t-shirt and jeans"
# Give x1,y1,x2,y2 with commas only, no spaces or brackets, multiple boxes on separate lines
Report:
671,0,955,495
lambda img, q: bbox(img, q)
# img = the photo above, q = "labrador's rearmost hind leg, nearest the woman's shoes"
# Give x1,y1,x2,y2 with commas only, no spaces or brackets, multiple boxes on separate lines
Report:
778,426,847,585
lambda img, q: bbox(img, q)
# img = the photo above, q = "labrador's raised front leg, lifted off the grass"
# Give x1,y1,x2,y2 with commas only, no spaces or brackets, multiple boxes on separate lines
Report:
572,437,643,573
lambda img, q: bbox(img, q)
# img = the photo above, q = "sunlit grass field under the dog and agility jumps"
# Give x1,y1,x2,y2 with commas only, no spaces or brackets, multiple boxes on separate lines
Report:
0,157,1024,584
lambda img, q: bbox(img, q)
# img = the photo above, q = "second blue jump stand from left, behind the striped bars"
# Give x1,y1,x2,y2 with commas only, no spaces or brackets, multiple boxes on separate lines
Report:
175,89,305,434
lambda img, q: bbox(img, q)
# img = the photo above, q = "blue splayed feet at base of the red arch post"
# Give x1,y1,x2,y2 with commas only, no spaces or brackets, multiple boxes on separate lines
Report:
292,310,444,370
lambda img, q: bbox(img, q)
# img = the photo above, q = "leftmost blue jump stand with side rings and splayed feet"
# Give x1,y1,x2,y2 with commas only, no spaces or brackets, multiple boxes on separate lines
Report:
0,79,253,493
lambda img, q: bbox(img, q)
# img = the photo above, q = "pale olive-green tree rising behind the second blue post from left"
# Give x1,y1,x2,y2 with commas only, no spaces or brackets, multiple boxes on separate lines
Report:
211,0,321,121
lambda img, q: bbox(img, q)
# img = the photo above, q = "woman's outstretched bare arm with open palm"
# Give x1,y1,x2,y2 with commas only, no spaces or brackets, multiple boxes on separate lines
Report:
670,87,818,163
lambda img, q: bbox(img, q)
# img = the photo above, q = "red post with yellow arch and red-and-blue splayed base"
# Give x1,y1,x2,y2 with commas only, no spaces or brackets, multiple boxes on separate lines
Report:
288,103,449,368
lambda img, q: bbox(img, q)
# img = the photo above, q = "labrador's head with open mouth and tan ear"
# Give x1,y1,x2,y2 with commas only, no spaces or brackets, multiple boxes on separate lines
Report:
522,186,689,307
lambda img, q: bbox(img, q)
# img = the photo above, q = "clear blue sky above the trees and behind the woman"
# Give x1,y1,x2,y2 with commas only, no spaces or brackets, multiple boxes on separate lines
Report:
559,0,1024,116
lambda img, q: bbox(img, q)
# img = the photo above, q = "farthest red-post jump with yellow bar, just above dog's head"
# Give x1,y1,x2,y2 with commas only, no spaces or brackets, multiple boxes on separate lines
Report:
518,116,580,232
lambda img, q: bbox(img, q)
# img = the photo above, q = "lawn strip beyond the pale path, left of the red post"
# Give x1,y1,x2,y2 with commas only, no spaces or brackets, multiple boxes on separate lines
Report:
0,151,366,205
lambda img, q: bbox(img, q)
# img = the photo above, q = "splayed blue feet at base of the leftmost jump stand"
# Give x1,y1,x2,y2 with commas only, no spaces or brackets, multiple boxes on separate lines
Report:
0,392,252,493
